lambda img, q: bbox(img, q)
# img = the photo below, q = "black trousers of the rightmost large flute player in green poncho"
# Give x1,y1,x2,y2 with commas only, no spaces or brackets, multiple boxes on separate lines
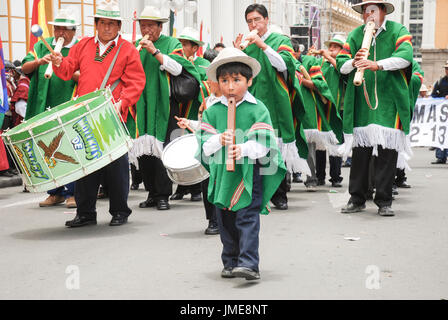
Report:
348,146,398,207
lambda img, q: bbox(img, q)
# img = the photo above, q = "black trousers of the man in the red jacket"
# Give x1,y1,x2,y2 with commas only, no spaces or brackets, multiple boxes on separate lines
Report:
75,154,132,218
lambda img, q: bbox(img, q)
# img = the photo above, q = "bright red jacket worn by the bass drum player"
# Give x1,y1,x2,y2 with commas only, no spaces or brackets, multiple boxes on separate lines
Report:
53,36,146,122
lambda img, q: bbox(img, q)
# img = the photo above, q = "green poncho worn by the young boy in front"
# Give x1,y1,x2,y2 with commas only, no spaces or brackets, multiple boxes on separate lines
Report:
197,100,286,214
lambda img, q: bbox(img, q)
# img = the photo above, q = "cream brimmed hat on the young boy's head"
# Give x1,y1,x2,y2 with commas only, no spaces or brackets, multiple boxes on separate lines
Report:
207,48,261,82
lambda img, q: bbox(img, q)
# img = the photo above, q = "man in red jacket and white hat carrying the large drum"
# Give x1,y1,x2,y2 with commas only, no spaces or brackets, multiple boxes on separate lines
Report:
51,0,145,228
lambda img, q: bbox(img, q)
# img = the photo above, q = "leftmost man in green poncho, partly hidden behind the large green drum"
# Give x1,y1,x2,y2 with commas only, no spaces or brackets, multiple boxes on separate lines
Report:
22,9,79,208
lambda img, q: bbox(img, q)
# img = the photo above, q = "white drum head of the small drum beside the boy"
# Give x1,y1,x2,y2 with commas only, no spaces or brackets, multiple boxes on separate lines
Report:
162,134,199,169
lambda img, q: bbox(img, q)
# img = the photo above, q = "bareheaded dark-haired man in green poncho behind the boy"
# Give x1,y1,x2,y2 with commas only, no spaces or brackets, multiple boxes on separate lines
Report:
234,4,310,210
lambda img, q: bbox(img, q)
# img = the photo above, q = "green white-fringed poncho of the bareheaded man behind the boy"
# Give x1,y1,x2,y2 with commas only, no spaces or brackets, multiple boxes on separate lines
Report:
244,33,310,173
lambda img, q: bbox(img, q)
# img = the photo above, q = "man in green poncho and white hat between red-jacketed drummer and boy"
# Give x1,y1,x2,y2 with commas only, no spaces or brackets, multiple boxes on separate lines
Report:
131,6,200,210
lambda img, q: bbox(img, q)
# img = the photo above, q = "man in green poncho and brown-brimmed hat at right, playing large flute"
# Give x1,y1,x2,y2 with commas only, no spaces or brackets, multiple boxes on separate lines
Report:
336,1,413,216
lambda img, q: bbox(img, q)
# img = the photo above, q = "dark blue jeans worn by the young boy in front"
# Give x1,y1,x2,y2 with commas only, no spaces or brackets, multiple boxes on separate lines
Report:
216,164,263,272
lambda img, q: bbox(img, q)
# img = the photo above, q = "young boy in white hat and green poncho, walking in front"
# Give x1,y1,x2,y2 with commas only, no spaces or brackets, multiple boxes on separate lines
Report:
197,48,286,280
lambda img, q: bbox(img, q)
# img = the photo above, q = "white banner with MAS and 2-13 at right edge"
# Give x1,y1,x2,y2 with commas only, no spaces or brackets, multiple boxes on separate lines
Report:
409,98,448,149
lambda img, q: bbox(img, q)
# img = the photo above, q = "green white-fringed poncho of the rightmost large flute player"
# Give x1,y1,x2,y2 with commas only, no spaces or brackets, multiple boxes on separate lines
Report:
336,21,413,155
